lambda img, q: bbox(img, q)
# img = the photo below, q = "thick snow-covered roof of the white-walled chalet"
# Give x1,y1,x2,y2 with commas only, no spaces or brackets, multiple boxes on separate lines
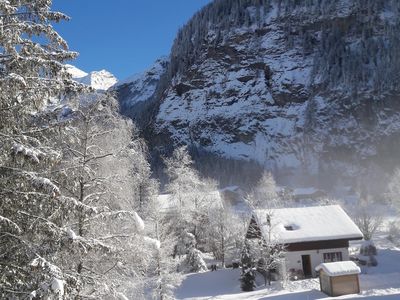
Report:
254,205,363,244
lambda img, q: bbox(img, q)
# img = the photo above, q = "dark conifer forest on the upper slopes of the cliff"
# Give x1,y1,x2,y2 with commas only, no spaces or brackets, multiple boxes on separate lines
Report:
164,0,400,92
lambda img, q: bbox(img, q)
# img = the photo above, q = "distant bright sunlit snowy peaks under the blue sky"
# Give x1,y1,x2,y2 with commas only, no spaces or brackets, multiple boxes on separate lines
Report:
66,65,118,91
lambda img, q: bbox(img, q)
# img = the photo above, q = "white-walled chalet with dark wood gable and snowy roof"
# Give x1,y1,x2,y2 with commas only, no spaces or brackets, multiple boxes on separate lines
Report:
246,205,363,277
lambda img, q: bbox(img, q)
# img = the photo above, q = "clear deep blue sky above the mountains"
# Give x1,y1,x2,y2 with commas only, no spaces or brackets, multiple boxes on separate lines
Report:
53,0,211,79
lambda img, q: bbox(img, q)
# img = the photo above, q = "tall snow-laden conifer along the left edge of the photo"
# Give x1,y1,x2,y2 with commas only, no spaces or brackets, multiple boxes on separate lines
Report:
0,0,82,299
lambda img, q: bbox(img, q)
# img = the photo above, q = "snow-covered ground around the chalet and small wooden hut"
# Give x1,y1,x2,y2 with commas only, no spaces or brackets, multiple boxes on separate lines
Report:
175,232,400,300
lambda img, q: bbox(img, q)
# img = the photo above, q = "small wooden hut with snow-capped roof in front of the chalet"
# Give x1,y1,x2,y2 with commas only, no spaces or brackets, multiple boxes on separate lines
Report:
315,261,361,297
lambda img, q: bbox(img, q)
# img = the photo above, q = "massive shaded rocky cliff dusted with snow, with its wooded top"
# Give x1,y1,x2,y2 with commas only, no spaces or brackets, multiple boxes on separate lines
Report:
114,0,400,188
